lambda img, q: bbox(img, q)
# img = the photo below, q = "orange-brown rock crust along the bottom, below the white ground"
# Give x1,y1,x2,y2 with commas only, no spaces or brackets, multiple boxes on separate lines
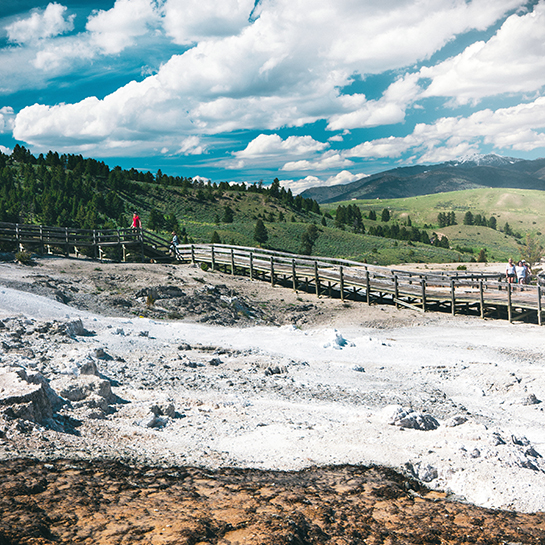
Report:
0,460,545,545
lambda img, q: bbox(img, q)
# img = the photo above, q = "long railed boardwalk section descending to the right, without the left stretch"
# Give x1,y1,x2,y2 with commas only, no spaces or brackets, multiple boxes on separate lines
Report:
177,244,542,325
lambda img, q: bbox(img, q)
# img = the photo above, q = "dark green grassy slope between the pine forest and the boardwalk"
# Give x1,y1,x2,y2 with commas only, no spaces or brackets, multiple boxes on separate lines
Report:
124,184,459,265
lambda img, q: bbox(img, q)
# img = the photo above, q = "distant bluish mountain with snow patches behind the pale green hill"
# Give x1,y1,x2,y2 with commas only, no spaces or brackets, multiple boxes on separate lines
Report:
301,154,545,204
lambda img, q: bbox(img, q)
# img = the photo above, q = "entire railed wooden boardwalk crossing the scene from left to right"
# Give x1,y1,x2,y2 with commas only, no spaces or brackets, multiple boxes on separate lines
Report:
0,223,543,325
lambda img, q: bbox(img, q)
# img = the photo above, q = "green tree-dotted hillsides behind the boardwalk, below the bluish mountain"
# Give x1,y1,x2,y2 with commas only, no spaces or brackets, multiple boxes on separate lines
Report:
0,146,545,265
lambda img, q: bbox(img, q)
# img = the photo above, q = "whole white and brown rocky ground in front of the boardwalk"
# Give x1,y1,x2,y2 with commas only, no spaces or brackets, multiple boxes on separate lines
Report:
0,256,545,545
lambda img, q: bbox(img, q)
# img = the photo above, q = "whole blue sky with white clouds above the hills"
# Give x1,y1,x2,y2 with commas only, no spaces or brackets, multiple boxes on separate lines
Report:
0,0,545,193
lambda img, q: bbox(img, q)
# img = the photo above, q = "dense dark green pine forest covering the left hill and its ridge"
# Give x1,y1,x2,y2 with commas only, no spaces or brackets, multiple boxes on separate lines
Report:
0,144,321,230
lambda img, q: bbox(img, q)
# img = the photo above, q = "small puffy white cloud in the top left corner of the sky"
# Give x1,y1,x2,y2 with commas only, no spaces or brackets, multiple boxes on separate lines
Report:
6,2,75,44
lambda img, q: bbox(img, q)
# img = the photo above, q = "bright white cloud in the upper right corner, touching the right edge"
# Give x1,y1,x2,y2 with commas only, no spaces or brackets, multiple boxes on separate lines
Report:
420,2,545,104
